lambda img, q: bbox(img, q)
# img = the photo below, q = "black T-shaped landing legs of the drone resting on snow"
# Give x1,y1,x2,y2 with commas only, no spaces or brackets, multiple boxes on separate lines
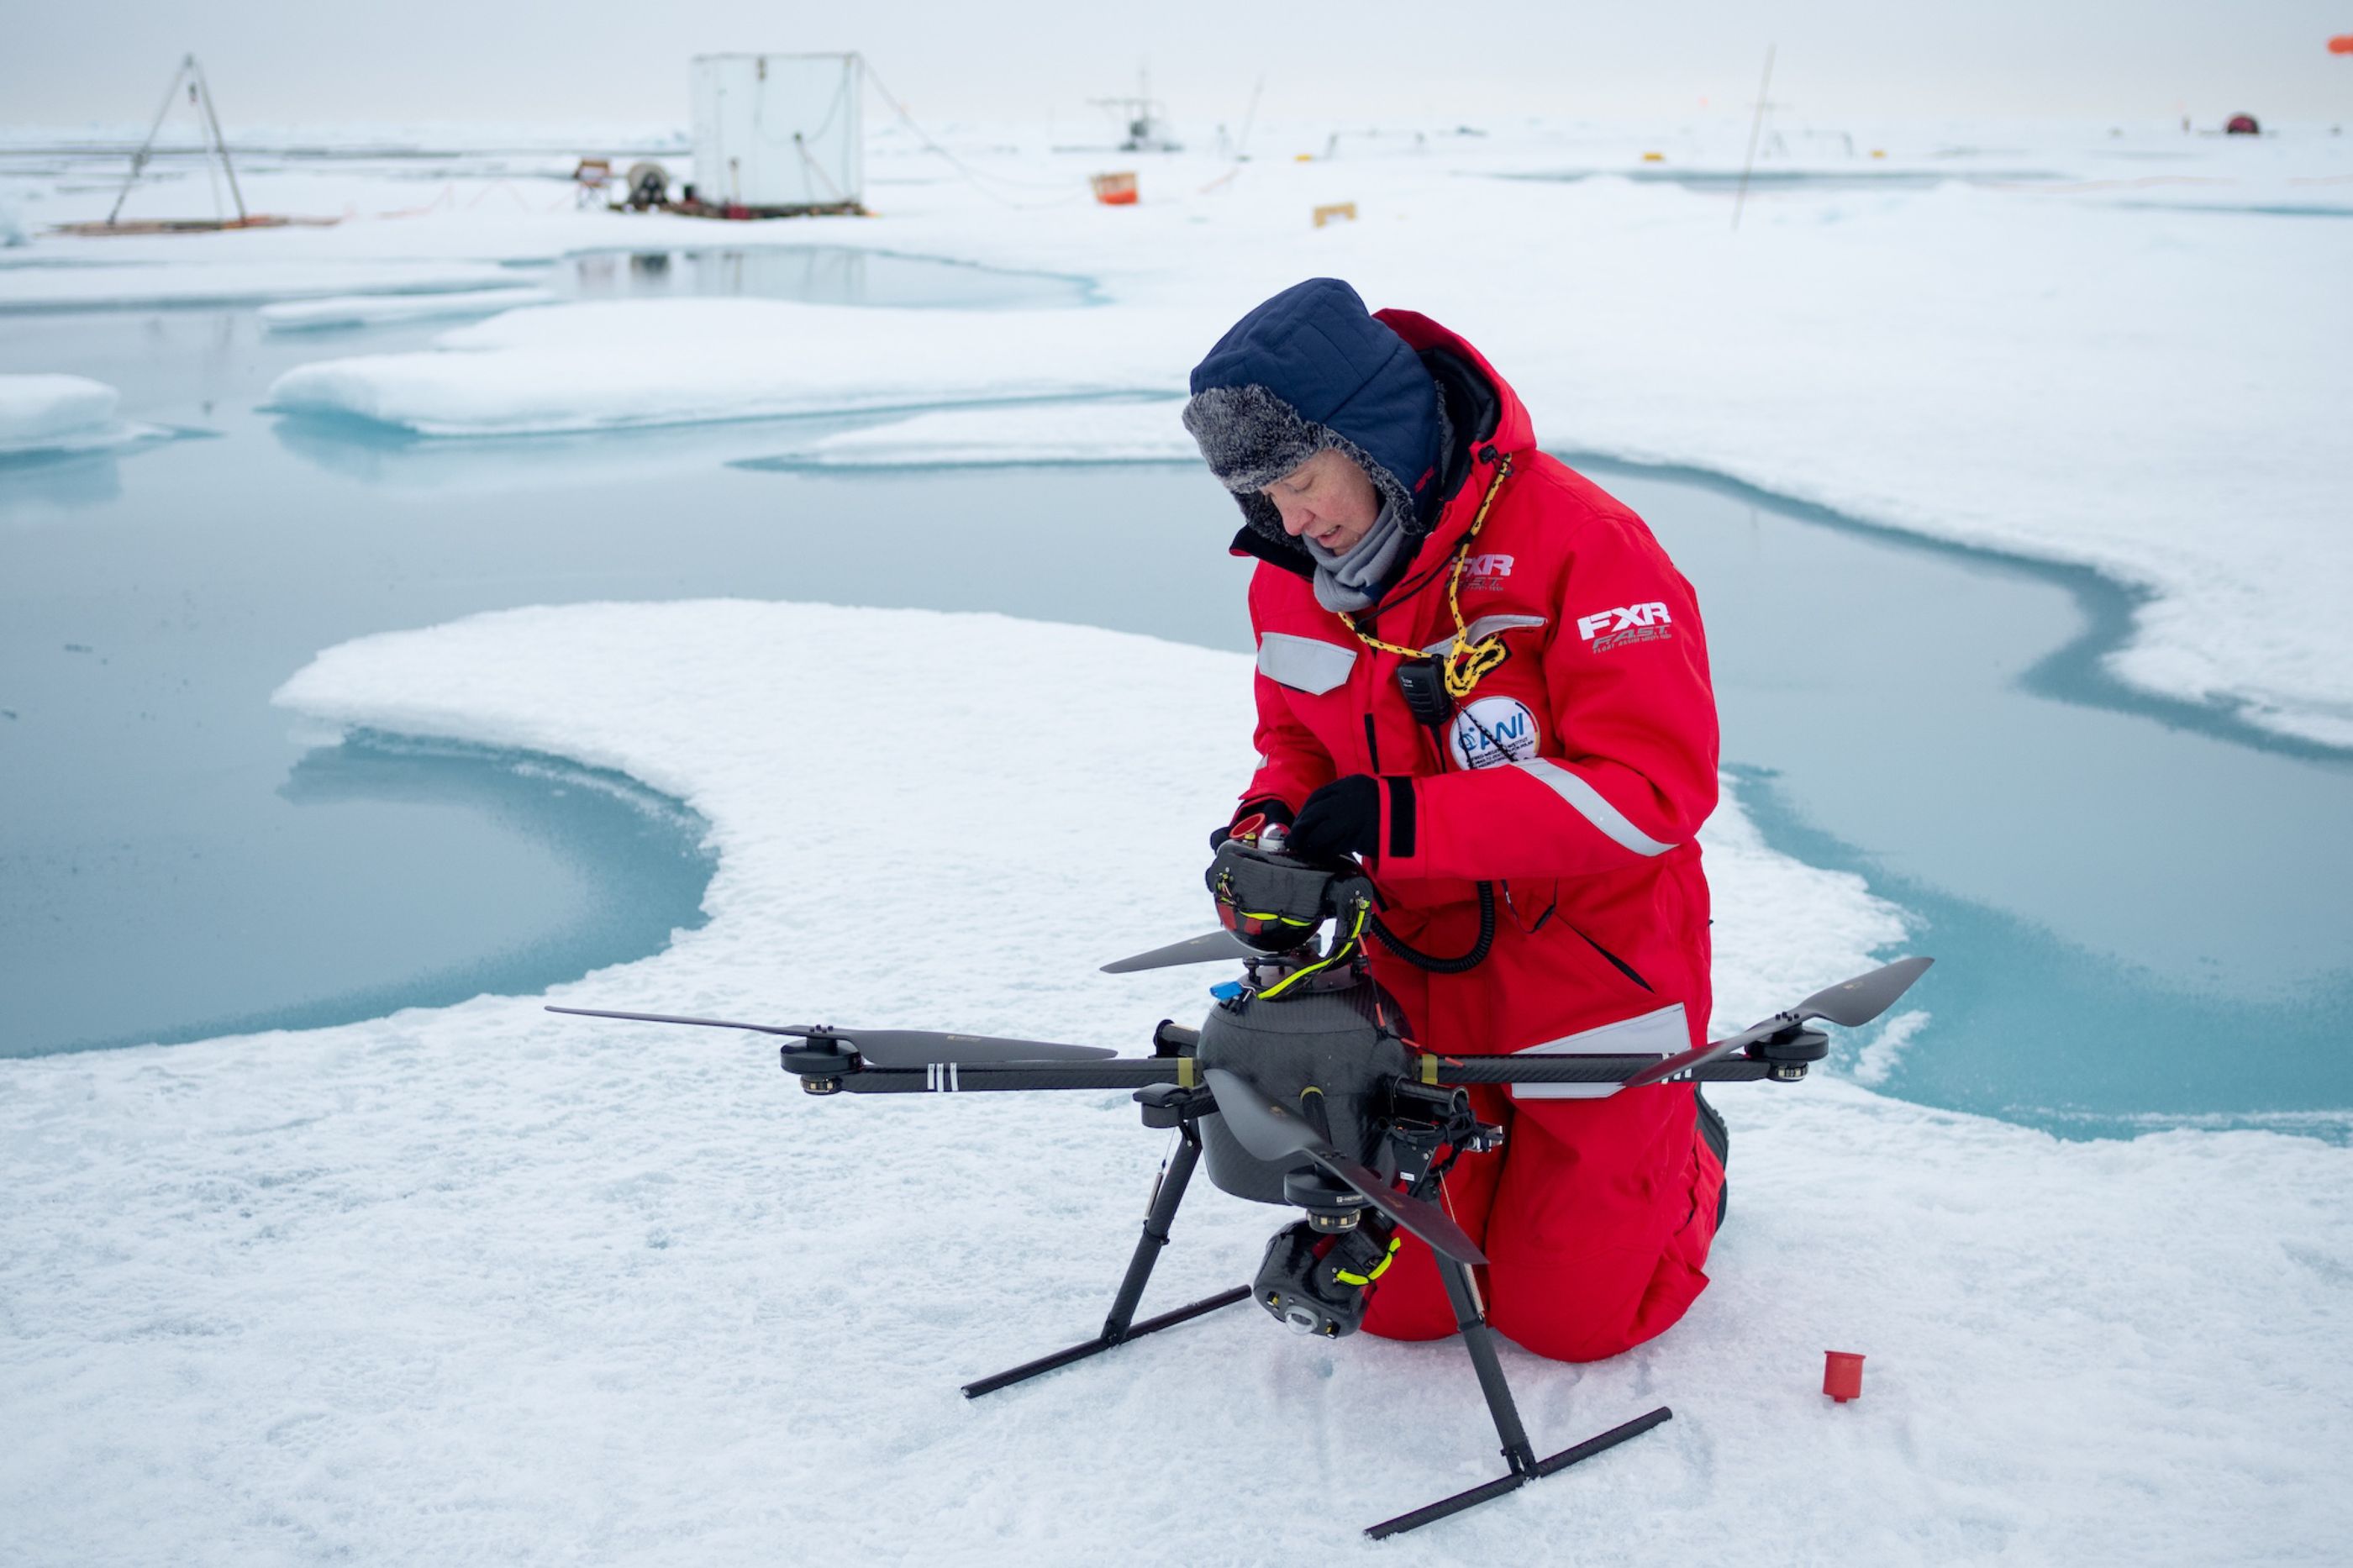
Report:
965,1087,1673,1539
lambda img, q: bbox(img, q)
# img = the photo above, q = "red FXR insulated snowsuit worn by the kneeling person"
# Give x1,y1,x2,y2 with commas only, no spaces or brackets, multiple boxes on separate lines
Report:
1242,311,1723,1360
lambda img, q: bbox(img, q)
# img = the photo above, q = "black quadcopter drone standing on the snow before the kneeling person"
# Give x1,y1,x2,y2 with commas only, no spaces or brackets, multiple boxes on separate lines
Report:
548,831,1932,1539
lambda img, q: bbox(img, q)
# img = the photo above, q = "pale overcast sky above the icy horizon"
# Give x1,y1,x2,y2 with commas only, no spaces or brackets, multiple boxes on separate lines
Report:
13,0,2353,134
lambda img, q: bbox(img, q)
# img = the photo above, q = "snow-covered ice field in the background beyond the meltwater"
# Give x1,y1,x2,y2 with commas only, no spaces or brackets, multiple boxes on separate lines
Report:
87,120,2315,746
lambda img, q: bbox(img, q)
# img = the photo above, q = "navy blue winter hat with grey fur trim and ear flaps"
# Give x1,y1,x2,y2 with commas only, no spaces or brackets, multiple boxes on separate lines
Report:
1183,278,1445,544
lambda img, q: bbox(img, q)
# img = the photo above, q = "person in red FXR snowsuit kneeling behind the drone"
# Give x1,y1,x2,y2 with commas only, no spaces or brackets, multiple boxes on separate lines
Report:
1183,278,1724,1360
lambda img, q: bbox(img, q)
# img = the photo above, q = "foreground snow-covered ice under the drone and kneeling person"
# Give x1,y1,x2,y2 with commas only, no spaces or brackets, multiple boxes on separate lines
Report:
0,602,2353,1568
